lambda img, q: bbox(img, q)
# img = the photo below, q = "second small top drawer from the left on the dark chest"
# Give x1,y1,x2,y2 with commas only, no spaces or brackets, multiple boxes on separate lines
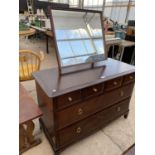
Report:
82,84,103,98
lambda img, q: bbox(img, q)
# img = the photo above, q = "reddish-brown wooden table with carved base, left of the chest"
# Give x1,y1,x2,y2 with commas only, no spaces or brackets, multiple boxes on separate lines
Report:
19,84,42,154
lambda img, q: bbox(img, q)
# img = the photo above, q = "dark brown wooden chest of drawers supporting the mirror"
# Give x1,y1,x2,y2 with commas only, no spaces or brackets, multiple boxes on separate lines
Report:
33,59,135,154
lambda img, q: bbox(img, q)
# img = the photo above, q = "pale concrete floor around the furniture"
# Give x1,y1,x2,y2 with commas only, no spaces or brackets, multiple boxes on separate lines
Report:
20,39,135,155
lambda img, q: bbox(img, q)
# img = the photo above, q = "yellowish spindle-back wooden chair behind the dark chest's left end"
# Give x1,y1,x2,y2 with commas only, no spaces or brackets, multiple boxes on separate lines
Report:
19,50,44,81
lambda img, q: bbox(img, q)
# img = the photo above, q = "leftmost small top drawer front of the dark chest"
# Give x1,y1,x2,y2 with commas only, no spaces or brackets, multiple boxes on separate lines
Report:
56,90,81,109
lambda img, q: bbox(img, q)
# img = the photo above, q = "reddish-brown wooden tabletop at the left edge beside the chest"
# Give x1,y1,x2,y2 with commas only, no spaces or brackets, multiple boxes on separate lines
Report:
19,84,42,124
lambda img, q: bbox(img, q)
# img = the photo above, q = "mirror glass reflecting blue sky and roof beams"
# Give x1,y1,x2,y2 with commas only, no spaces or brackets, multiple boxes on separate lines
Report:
51,10,106,67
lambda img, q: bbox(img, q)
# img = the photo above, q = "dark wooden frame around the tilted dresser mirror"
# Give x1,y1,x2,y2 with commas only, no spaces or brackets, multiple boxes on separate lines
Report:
48,6,107,74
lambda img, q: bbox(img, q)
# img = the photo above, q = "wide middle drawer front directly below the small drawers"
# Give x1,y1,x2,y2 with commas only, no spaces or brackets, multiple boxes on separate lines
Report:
56,84,133,129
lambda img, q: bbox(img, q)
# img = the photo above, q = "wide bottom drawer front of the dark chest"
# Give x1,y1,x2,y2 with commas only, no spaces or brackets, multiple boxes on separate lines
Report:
58,99,129,147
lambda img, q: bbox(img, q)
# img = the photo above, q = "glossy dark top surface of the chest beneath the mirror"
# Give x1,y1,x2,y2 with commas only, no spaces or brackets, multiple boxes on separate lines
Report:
33,58,135,97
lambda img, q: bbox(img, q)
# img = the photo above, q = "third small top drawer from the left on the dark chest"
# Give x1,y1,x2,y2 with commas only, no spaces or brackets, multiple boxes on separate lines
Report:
105,77,123,91
